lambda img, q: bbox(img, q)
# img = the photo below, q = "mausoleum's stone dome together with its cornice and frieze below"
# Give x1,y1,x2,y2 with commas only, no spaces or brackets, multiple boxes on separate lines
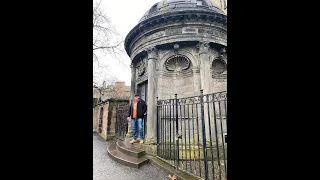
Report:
124,0,227,59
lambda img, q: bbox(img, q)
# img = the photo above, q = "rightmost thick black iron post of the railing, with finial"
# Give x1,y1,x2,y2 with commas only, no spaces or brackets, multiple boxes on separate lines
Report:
200,89,209,179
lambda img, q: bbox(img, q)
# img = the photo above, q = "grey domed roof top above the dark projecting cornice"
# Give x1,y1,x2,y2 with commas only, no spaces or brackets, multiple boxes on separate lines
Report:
139,0,225,23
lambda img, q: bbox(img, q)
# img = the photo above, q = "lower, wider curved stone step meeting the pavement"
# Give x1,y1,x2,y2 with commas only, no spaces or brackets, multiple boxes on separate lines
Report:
107,143,149,169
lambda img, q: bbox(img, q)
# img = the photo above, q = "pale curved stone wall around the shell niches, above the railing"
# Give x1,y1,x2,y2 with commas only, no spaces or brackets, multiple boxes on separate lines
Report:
157,46,227,99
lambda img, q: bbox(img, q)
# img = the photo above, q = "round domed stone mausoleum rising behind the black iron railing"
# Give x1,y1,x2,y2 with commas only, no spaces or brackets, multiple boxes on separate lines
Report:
125,0,227,144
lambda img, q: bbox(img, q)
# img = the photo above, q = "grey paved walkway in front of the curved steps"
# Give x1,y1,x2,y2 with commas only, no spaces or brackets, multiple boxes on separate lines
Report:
93,135,167,180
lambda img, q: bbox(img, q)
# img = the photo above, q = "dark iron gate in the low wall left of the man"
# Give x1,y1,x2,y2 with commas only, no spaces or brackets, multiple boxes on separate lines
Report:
116,104,129,140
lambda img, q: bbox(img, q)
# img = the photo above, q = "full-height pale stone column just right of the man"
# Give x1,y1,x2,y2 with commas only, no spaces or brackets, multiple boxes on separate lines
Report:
145,47,158,144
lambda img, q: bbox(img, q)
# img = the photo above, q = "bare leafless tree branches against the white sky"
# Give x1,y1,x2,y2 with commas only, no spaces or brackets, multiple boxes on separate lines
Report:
93,0,125,86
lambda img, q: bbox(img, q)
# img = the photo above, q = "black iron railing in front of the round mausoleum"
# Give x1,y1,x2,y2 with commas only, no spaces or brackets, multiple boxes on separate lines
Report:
157,91,227,180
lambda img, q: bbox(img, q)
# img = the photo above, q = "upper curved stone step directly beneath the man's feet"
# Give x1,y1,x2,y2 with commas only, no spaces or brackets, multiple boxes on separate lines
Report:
116,141,146,158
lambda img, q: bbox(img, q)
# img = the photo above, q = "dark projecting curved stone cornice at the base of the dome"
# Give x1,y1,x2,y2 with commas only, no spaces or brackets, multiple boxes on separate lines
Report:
125,9,227,56
